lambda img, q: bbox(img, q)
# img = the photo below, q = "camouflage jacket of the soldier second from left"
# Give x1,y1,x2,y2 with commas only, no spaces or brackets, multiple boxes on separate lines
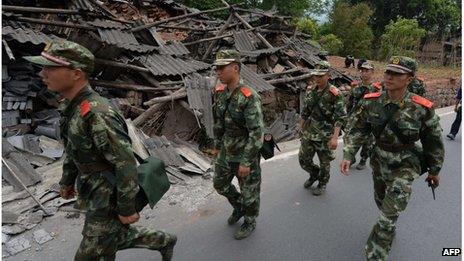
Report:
213,80,264,166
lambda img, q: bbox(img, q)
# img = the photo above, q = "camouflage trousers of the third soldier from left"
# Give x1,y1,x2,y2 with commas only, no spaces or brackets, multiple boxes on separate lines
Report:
298,137,335,185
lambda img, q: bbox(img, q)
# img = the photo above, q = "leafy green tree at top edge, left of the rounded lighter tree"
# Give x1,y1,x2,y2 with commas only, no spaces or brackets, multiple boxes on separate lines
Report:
329,1,374,58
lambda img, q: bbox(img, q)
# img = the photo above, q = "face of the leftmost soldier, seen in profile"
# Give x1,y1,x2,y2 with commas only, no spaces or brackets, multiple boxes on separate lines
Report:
39,66,75,93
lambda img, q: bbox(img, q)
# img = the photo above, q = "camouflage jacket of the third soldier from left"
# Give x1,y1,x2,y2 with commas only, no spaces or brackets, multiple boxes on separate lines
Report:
301,84,346,141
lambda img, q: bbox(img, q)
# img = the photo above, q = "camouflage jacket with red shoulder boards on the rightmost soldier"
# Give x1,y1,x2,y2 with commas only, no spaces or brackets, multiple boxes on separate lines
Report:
343,91,444,175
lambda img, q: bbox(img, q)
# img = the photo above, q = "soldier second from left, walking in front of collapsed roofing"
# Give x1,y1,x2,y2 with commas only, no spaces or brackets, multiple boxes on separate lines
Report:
213,50,264,240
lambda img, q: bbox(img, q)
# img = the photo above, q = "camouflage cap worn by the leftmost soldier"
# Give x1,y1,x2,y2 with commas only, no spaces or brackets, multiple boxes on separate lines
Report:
24,40,95,73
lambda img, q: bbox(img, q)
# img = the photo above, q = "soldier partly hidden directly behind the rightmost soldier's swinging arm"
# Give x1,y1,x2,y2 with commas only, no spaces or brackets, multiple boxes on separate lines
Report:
347,62,382,170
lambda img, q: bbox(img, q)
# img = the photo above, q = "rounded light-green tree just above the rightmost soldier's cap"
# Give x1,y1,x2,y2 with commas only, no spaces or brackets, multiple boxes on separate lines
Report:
380,18,426,59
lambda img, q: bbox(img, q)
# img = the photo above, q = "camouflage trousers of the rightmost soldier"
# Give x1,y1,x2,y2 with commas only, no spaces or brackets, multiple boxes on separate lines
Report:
364,148,420,260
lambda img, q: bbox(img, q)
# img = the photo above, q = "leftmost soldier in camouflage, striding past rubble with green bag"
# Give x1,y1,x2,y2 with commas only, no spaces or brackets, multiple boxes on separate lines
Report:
24,41,177,260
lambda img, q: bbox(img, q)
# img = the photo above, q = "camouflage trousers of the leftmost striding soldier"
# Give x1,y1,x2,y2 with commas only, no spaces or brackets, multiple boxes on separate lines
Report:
74,211,175,261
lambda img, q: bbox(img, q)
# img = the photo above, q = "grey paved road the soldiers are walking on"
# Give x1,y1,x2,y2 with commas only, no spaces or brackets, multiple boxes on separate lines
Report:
9,106,461,261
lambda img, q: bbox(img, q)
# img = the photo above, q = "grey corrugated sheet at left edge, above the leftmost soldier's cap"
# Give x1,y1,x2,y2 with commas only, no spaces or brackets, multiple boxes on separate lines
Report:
2,26,61,45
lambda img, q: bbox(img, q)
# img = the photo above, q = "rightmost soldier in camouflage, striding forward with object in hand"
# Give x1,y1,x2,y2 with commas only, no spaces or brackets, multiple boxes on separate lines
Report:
340,56,444,260
